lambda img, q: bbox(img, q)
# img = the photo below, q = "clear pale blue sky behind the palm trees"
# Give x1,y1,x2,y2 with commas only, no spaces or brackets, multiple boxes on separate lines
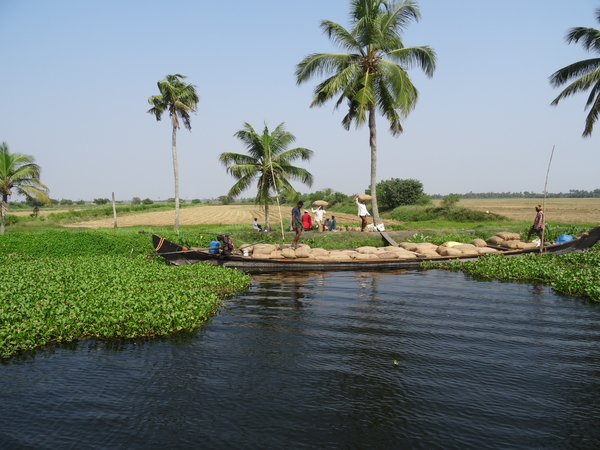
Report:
0,0,600,201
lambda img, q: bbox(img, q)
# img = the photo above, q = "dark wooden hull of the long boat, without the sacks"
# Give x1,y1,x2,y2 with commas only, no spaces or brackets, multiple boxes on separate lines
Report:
152,227,600,272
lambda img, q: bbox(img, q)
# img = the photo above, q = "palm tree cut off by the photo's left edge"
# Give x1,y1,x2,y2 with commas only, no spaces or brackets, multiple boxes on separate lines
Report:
0,142,50,234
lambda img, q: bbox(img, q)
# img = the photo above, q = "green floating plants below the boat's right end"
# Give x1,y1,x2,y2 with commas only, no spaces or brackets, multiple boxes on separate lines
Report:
422,246,600,301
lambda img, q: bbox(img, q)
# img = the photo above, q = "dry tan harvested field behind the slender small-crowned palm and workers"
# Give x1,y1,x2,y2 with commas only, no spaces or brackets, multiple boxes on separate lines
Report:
67,205,394,228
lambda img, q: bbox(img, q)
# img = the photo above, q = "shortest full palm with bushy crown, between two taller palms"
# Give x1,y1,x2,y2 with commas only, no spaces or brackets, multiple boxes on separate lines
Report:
219,123,313,229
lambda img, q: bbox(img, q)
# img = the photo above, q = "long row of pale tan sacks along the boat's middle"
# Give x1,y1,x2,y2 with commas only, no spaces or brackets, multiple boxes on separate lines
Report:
242,239,498,260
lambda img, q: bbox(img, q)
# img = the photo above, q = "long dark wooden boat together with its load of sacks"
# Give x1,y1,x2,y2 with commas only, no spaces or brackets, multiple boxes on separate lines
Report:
152,227,600,271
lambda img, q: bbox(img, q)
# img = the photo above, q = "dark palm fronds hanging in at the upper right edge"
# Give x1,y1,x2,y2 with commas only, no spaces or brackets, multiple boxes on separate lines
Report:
550,8,600,137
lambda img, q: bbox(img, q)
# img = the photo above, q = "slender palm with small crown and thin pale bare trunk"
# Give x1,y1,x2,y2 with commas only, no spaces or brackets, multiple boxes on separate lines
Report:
148,74,200,230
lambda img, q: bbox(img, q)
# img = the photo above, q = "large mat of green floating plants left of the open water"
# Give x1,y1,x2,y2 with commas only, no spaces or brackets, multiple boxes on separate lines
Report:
0,230,248,357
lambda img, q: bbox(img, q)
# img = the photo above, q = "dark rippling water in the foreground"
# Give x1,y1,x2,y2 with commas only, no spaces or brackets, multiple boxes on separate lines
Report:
0,271,600,449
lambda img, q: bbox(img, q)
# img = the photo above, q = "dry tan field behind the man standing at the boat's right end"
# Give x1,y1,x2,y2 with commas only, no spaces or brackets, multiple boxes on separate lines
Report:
450,198,600,224
